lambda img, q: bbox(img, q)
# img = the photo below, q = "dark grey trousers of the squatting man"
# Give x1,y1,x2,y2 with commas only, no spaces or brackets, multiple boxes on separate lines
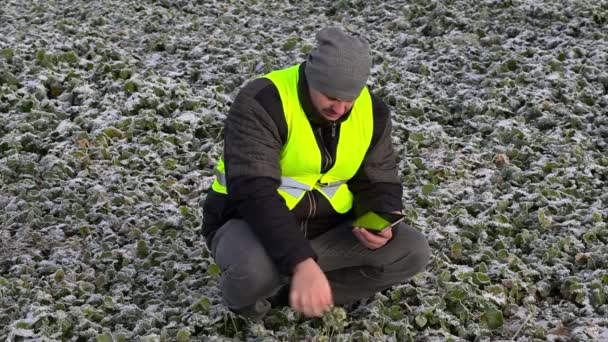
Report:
211,219,430,319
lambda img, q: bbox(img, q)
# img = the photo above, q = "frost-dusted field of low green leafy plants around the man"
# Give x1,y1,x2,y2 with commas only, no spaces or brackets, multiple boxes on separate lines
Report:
0,0,608,342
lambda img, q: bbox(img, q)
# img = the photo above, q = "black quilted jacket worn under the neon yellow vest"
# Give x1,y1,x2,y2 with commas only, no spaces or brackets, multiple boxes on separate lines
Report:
203,63,403,274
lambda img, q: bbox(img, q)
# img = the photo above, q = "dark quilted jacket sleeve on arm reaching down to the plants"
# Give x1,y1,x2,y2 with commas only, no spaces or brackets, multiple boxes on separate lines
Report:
224,79,316,274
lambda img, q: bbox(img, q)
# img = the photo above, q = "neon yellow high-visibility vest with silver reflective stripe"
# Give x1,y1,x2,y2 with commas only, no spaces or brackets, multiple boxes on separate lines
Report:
212,65,374,213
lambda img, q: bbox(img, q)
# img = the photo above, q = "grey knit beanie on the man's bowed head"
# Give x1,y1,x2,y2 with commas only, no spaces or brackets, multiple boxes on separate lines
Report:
305,27,372,100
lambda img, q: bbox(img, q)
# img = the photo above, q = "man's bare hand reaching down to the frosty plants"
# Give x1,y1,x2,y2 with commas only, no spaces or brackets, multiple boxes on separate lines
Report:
289,258,334,317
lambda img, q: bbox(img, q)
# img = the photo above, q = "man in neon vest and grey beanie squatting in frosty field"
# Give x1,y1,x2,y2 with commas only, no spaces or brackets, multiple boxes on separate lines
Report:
203,28,430,319
